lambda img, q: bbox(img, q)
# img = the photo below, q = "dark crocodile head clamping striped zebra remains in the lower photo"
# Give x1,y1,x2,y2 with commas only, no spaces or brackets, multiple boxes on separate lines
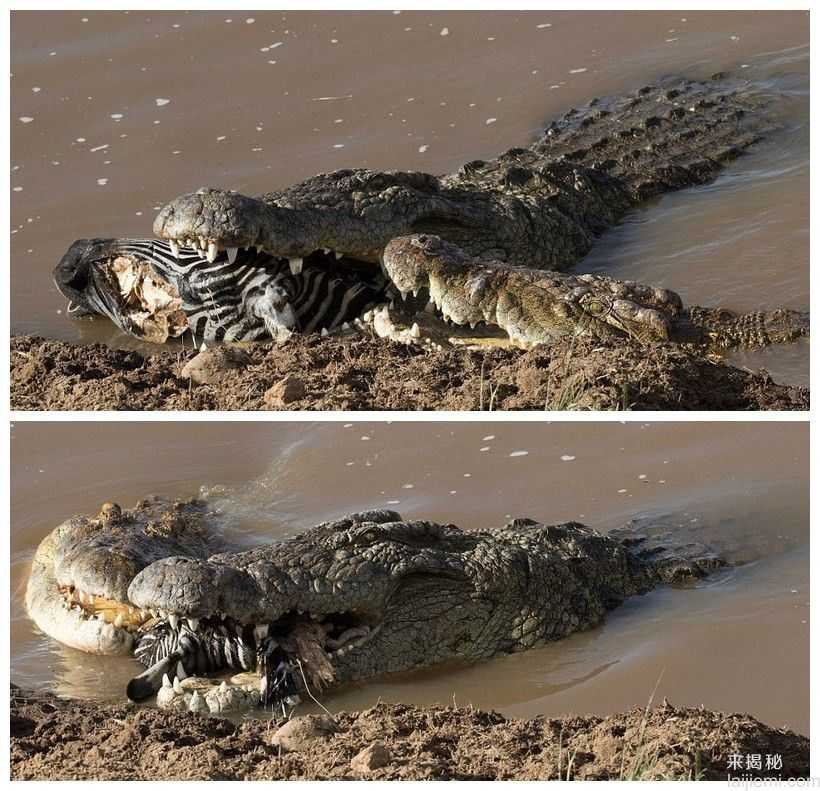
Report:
123,510,494,703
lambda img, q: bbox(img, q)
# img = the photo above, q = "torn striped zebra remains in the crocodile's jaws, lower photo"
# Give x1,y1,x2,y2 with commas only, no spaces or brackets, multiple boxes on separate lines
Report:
127,611,380,710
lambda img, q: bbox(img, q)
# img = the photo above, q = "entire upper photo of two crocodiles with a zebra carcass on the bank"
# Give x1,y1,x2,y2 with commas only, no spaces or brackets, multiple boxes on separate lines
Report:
10,10,810,411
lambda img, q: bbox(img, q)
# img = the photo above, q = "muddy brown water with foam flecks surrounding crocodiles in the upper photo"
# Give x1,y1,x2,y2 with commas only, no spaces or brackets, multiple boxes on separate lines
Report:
11,11,809,384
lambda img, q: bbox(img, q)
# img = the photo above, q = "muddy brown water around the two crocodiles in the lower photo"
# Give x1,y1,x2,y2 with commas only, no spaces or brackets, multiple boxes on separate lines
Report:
11,422,809,734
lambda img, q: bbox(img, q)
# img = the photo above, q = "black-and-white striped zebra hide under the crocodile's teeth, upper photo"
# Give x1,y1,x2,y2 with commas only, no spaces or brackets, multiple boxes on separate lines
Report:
117,239,386,341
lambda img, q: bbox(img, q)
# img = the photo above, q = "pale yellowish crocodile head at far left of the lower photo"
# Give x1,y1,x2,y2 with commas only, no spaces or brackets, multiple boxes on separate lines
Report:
26,499,217,654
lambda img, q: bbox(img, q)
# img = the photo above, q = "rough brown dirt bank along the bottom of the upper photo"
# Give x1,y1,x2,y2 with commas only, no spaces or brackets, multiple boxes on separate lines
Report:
11,335,809,410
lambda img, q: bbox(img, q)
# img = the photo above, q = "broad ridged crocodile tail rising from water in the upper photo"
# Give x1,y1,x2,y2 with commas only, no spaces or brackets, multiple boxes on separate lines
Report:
532,74,775,203
